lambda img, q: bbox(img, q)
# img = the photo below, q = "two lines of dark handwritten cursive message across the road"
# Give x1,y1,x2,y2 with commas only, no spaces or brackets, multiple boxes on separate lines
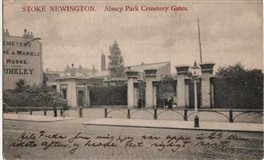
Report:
9,131,249,154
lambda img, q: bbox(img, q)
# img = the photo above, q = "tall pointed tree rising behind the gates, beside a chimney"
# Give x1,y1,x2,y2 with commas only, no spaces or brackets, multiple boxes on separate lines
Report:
108,42,125,77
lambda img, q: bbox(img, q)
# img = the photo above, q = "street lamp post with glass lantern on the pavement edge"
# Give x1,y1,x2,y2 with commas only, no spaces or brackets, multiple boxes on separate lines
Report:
190,61,201,127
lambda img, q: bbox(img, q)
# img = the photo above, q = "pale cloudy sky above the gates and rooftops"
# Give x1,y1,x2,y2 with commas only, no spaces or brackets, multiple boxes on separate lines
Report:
3,0,263,72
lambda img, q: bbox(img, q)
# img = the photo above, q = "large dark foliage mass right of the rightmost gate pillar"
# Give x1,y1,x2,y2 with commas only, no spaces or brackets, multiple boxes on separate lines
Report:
213,63,263,108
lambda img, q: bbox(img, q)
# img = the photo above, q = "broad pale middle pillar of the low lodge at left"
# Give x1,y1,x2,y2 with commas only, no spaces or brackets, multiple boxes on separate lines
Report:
67,82,77,108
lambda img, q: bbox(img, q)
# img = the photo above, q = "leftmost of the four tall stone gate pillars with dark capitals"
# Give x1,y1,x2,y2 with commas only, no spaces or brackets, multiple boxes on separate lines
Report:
126,71,138,107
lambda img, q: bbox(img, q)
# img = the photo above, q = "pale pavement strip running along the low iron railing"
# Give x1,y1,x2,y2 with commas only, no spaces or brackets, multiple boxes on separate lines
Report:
3,114,264,132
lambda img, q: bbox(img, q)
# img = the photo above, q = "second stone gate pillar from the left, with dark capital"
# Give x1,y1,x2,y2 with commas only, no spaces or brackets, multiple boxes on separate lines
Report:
145,69,157,108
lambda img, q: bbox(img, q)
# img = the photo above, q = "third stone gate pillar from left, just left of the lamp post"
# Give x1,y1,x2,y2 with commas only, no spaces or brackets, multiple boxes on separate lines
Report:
176,66,190,107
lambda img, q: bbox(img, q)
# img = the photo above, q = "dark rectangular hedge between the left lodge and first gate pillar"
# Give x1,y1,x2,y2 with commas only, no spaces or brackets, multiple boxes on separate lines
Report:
90,85,127,105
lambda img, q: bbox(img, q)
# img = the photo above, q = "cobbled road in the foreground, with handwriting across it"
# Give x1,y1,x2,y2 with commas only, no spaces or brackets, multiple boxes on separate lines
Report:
3,119,263,160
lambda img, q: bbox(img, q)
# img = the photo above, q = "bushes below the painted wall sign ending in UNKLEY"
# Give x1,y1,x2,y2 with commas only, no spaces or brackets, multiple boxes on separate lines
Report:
3,80,67,108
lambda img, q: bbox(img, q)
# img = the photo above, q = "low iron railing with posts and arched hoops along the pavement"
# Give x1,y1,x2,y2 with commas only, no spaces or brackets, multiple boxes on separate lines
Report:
3,104,264,123
